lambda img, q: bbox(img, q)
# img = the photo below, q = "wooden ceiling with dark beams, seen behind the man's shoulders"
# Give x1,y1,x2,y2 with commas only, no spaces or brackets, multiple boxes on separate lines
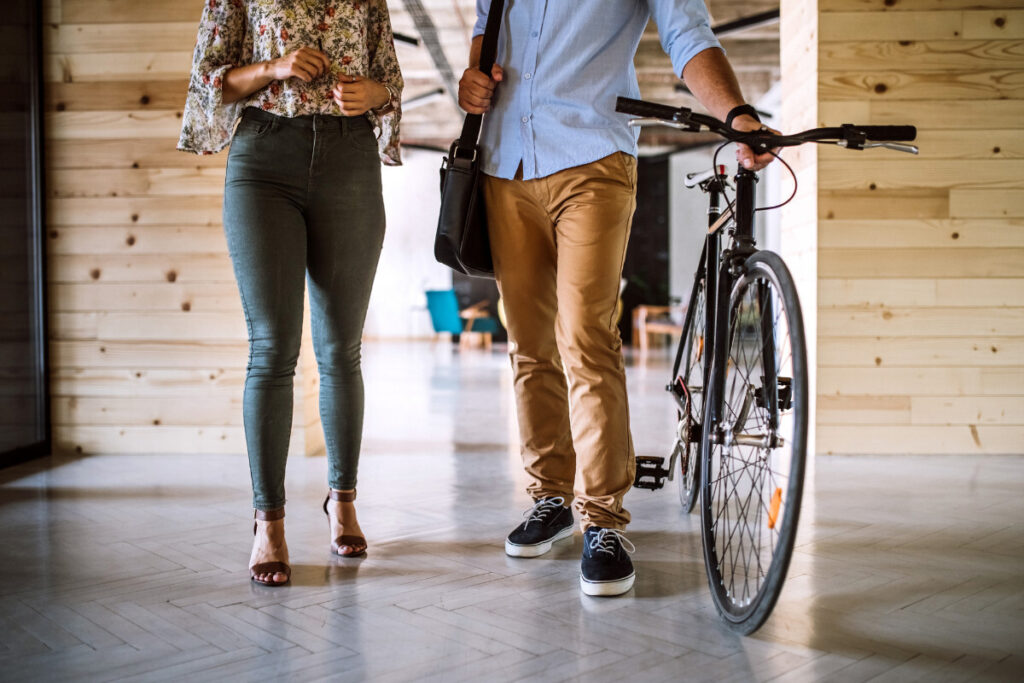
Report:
388,0,779,148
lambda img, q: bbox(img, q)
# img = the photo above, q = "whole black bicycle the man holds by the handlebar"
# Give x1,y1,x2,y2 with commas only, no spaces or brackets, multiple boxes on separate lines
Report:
615,97,918,634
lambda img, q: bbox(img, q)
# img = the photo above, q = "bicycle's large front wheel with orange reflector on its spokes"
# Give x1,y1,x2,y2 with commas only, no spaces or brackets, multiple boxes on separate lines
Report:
700,251,808,634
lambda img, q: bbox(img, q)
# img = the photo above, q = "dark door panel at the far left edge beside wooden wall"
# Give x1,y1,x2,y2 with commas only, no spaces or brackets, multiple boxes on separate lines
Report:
0,0,50,467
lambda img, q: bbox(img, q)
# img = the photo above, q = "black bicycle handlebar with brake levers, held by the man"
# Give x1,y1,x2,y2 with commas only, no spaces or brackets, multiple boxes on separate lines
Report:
615,97,918,154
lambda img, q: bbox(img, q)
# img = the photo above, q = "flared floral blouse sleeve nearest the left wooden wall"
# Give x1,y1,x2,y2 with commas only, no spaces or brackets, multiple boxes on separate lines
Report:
178,0,247,154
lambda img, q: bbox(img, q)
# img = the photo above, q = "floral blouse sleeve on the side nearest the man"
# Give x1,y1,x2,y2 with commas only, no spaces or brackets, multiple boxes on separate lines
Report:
367,0,406,166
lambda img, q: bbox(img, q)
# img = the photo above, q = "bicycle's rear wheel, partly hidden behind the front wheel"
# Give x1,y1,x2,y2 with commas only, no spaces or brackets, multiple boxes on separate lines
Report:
673,272,708,513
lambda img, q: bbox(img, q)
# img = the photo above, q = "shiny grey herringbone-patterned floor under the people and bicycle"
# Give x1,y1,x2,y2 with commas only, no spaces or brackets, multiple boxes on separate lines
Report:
0,343,1024,683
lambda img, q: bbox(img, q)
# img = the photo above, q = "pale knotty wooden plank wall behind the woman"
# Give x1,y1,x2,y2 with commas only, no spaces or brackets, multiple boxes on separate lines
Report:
44,0,323,453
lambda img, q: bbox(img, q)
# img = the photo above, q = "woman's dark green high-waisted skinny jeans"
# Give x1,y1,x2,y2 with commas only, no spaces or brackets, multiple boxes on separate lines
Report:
224,108,384,510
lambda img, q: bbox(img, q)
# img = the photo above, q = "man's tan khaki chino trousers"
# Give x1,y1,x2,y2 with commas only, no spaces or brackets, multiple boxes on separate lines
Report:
483,153,636,529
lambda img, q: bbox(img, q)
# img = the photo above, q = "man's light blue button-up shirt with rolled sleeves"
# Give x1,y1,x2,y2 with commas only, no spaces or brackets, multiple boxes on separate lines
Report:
473,0,721,180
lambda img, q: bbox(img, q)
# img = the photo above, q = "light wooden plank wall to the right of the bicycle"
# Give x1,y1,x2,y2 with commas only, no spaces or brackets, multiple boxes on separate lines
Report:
798,0,1024,454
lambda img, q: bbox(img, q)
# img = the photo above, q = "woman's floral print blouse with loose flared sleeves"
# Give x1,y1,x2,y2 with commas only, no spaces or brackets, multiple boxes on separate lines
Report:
178,0,403,166
